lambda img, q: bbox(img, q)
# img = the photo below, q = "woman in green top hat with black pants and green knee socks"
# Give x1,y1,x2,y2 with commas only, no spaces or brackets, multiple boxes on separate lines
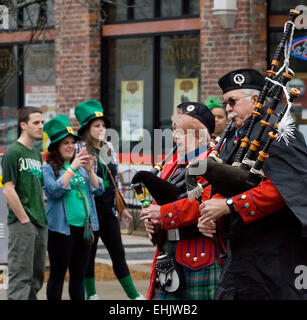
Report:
75,100,144,300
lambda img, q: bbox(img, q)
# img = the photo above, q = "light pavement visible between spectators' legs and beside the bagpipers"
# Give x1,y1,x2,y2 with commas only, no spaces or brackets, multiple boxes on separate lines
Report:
0,235,154,300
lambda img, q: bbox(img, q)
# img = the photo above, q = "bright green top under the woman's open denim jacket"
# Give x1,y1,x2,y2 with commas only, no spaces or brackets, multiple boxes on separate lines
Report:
64,163,90,227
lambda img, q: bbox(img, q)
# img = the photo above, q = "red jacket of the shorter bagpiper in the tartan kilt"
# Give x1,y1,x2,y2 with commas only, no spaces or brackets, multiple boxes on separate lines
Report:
147,152,224,299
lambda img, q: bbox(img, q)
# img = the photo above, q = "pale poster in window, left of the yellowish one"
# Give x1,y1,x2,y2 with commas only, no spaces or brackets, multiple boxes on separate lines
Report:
120,80,144,141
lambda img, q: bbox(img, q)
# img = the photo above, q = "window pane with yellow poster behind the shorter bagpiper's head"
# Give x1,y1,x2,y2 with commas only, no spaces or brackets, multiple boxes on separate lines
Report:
159,33,200,129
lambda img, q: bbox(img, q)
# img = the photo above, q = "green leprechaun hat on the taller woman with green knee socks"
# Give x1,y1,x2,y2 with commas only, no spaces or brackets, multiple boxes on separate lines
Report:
75,100,111,136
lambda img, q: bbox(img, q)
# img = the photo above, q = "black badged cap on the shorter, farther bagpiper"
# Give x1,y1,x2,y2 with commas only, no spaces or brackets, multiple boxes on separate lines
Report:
177,102,215,134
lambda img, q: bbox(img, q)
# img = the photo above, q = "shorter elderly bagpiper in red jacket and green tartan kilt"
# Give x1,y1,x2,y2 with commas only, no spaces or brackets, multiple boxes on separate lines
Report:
141,102,226,300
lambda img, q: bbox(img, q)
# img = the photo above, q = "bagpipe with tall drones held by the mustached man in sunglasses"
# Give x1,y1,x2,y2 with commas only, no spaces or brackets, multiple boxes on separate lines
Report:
185,9,300,200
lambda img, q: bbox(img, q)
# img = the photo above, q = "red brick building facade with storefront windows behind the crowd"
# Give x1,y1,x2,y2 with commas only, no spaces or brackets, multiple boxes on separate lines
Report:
0,0,307,159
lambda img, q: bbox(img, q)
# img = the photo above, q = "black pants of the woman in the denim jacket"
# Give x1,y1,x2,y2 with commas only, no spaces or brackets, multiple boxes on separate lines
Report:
47,226,90,300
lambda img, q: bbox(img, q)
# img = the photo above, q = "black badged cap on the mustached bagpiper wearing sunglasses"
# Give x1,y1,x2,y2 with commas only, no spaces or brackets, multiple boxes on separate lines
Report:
218,69,265,94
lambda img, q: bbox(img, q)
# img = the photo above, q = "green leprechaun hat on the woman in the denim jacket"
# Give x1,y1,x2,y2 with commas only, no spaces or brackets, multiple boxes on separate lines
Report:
44,114,81,151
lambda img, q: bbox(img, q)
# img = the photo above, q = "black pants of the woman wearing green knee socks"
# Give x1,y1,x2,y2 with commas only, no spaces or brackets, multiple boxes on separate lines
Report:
86,208,130,279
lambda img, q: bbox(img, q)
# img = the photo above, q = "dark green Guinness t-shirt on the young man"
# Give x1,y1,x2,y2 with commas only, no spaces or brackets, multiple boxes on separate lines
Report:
2,141,47,226
